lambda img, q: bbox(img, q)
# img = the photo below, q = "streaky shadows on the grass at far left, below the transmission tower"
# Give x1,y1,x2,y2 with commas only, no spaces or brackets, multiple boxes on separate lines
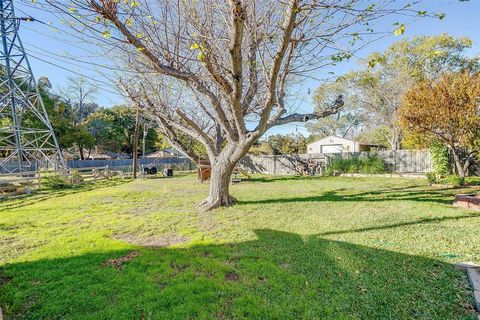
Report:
0,179,133,212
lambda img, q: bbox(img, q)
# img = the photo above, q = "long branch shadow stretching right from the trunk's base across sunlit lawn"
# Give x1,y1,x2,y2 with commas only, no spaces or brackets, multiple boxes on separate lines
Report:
238,186,462,205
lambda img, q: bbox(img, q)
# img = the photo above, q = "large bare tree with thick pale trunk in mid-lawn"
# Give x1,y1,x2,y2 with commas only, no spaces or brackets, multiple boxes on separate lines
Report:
47,0,428,209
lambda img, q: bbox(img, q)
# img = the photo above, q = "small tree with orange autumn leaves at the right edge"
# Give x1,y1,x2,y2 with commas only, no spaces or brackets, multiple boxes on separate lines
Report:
400,72,480,177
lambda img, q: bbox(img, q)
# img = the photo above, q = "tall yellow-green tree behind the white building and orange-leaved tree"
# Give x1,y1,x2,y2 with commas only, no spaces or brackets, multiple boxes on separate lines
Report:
310,33,480,149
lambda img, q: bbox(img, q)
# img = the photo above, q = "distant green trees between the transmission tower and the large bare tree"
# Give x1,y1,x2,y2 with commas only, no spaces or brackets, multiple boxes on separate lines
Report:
39,77,161,160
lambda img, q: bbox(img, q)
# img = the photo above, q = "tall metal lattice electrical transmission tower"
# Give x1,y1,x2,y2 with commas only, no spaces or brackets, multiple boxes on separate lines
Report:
0,0,66,172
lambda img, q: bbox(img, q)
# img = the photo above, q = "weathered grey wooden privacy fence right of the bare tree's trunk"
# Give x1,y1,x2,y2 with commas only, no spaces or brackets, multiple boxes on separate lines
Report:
240,150,432,175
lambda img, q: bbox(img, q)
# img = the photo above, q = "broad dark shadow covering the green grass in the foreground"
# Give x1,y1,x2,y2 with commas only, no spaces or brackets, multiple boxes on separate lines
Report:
0,230,474,320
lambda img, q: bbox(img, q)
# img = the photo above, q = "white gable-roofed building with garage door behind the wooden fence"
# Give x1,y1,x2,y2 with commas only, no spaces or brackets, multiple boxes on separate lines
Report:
307,136,381,153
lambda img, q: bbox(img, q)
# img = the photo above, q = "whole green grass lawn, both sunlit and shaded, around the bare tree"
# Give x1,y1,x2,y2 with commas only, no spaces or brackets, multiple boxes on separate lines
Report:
0,176,480,320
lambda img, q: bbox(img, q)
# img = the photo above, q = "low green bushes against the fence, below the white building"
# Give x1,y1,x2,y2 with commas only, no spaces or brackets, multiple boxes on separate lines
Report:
326,155,385,175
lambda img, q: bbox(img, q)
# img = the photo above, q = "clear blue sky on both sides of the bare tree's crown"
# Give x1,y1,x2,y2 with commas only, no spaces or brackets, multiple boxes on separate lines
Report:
16,0,480,134
